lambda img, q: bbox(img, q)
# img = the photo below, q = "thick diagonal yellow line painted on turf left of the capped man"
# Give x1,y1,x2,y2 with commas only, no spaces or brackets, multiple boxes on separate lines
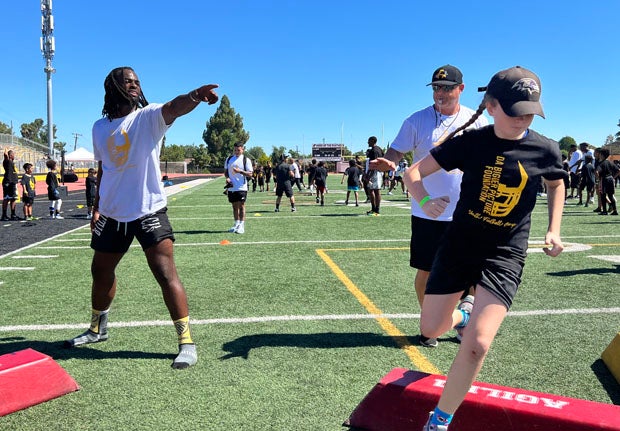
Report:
316,249,442,374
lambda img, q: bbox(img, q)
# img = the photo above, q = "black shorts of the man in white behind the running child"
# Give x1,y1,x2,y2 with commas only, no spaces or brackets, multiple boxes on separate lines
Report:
409,216,450,272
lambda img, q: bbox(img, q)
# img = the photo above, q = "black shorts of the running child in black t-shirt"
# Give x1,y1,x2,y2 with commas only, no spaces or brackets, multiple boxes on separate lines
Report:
426,228,527,309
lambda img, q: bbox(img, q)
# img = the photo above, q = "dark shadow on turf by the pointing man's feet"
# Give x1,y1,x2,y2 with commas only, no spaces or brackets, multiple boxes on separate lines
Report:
0,337,176,360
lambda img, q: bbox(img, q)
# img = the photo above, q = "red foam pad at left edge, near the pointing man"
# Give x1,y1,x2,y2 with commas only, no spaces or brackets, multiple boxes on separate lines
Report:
0,349,80,416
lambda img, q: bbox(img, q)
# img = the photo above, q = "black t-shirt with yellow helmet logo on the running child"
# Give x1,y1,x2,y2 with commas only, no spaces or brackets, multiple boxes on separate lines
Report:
431,125,566,247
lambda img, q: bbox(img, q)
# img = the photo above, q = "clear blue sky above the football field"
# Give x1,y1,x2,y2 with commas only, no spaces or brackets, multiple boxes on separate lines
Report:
0,0,620,154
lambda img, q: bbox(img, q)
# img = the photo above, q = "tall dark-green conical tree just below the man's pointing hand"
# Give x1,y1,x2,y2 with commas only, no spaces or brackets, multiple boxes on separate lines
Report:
202,95,250,166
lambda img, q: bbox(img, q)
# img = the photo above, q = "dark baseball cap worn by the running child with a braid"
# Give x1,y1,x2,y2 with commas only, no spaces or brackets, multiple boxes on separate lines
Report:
481,66,545,118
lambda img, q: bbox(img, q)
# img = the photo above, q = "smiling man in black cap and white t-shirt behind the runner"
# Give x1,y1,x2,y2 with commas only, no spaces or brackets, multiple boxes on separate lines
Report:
371,64,489,347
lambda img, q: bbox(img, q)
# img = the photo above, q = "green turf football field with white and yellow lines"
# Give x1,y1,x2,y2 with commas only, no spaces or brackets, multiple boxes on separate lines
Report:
0,174,620,431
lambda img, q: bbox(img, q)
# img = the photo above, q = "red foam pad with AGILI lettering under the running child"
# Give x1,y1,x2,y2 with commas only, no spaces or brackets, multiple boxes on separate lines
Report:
344,368,620,431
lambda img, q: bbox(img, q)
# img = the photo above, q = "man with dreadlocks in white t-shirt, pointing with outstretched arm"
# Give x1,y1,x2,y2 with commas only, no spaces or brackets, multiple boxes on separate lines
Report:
65,67,218,369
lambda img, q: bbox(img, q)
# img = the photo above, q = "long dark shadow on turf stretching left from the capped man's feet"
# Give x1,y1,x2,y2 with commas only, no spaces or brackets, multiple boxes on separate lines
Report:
219,332,456,361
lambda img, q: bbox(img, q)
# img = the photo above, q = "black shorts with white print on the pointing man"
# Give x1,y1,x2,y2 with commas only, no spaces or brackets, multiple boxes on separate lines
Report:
90,208,174,253
